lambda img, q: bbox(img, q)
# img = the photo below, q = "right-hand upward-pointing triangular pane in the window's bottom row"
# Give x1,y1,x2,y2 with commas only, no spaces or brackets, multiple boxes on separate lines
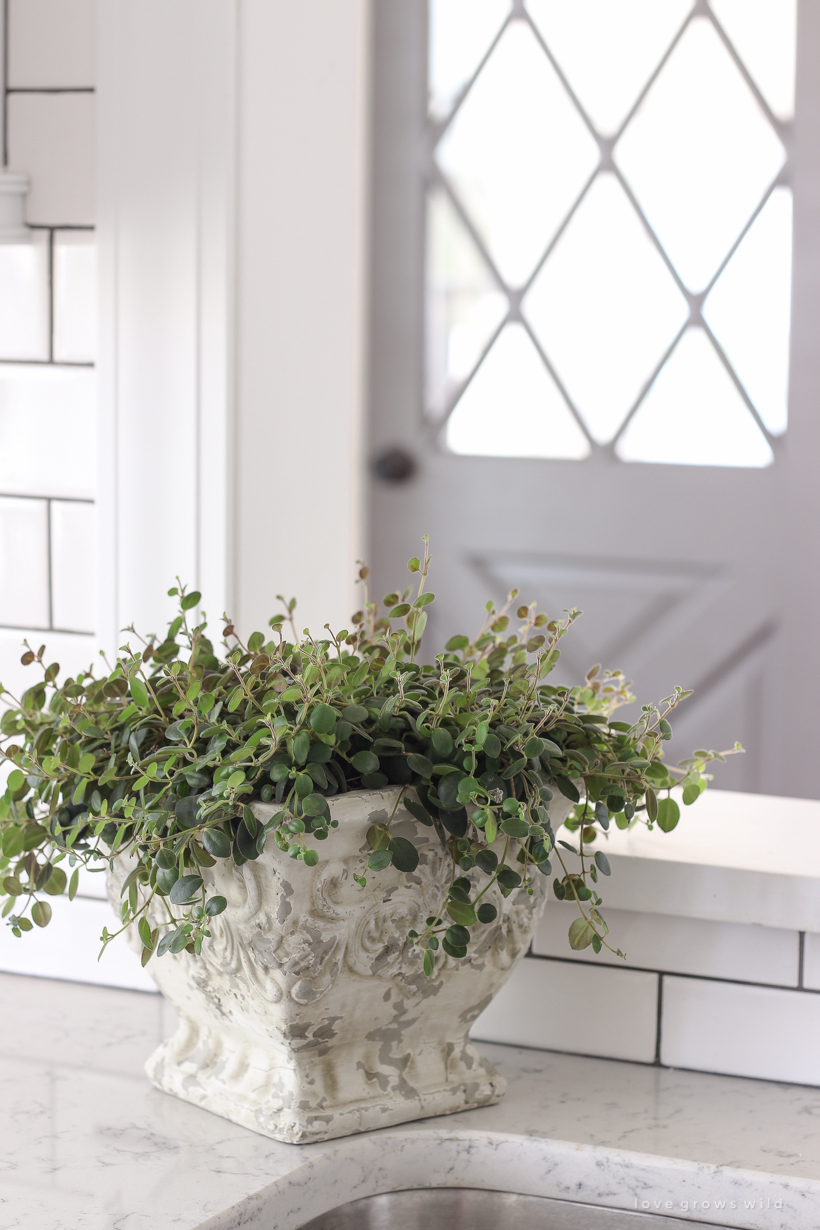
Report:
616,328,772,466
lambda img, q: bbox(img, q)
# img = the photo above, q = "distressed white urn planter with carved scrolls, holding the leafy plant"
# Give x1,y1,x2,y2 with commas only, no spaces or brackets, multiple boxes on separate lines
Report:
111,787,572,1143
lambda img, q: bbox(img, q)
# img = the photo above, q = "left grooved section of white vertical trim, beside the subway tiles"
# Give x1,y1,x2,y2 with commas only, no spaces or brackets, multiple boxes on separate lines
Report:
97,0,236,646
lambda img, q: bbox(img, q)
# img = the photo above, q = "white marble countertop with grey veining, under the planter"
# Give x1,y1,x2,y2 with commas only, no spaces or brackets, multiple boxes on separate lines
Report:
0,974,820,1230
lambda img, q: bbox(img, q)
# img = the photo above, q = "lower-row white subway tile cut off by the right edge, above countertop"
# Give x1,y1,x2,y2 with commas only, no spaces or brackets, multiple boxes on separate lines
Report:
660,977,820,1085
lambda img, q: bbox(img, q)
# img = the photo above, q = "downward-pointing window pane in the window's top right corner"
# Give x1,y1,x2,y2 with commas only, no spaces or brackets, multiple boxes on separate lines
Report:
712,0,797,119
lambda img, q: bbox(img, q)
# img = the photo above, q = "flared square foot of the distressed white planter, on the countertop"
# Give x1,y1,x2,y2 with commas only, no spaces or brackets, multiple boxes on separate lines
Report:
145,1021,507,1144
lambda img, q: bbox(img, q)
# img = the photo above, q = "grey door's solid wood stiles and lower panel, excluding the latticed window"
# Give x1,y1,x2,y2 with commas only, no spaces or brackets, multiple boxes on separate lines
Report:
370,0,820,797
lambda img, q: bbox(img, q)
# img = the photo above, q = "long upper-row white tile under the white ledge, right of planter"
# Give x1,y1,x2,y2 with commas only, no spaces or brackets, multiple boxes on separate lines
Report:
532,902,799,986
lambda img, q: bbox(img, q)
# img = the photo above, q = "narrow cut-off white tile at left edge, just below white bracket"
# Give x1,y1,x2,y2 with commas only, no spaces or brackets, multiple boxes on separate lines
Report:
0,231,49,359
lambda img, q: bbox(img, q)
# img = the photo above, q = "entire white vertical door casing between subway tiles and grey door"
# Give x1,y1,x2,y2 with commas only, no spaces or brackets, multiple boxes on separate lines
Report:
97,0,369,643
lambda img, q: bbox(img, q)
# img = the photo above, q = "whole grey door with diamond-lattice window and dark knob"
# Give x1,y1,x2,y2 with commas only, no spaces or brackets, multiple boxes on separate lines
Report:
371,0,820,795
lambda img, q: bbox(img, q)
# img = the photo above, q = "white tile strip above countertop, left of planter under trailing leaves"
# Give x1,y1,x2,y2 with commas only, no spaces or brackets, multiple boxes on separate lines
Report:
0,897,156,991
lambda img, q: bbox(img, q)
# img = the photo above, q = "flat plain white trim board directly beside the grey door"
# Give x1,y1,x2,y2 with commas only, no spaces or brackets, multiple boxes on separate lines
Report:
235,0,370,632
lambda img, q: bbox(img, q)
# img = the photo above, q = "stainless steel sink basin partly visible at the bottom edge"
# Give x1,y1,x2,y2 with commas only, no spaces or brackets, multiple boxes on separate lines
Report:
301,1187,729,1230
